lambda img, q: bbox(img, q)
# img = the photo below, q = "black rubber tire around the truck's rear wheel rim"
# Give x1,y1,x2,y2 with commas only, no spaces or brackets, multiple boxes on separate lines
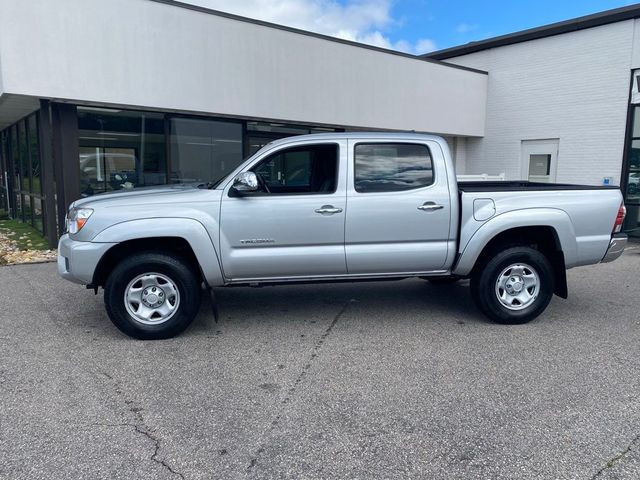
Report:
471,247,554,325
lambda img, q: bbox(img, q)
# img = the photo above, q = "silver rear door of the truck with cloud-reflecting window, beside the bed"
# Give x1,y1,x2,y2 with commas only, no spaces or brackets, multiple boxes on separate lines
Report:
345,139,452,274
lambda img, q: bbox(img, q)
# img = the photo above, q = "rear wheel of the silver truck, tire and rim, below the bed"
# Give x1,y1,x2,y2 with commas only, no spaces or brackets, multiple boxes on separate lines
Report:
471,247,554,325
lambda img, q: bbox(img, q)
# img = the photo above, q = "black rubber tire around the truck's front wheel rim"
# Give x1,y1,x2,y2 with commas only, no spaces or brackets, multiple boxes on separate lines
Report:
104,252,202,340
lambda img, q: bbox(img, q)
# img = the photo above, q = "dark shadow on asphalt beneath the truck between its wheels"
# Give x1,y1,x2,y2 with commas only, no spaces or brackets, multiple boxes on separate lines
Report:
185,279,488,335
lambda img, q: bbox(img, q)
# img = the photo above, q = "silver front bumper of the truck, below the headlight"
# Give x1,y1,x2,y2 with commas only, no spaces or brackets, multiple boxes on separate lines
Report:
58,234,116,285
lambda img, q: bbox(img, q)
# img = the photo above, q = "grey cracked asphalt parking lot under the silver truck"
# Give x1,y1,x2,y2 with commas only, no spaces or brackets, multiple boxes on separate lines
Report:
0,248,640,479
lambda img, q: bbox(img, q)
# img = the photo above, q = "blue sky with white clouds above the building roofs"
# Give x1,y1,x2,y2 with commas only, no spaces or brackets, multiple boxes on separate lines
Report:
183,0,634,55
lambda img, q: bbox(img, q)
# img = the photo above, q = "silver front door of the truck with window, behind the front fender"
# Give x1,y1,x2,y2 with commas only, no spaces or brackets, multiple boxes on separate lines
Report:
220,140,347,281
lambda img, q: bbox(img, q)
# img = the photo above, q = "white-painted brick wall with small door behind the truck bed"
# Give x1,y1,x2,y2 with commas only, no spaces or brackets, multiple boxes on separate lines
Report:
447,20,638,184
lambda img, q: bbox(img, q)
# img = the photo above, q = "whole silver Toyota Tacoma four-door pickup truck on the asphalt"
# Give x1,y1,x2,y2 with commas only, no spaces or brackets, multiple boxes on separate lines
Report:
58,132,626,339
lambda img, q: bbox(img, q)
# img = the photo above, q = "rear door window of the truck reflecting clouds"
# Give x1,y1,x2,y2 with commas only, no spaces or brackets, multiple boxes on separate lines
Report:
354,143,434,193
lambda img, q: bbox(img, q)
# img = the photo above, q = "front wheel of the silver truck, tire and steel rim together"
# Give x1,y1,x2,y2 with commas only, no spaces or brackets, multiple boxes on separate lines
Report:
104,253,201,340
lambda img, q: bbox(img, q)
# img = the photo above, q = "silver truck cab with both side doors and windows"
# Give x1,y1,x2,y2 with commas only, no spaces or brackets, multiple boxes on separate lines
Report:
220,135,458,282
